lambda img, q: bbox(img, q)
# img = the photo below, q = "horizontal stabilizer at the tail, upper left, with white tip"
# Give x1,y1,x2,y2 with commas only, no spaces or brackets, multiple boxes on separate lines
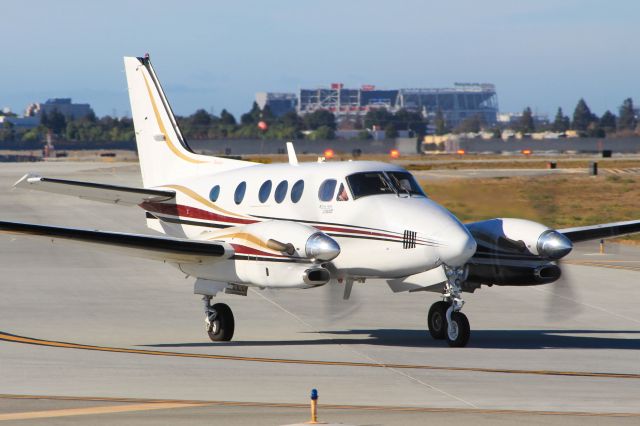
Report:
13,173,176,206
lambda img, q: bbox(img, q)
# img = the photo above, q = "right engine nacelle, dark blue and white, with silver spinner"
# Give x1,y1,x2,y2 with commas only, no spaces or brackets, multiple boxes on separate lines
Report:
467,218,573,260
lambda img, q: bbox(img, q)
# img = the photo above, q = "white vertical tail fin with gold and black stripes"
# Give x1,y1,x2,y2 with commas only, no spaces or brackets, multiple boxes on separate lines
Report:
124,56,253,188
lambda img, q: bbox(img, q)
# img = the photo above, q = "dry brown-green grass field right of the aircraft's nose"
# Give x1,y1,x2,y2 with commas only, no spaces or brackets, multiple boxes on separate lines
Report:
421,176,640,241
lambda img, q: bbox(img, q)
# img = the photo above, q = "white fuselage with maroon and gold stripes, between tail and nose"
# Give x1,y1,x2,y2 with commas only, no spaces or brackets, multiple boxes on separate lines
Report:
142,162,475,286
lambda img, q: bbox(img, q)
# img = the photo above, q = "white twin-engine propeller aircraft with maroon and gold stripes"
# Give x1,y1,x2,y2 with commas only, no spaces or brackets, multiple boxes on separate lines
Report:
5,56,640,346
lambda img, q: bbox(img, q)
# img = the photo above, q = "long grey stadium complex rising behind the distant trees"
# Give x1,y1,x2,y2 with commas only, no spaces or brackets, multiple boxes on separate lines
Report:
256,83,498,127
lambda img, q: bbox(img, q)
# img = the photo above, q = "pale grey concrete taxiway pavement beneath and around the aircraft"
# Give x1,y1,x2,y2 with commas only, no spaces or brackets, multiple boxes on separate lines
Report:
0,162,640,425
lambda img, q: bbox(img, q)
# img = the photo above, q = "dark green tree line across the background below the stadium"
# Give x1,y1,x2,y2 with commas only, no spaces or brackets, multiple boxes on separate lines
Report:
0,98,638,148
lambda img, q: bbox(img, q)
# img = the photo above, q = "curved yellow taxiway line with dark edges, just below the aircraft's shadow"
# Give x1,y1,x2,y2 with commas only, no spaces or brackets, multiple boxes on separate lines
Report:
0,332,640,379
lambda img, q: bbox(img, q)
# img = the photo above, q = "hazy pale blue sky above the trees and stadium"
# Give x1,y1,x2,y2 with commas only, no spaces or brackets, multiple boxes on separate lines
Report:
0,0,640,115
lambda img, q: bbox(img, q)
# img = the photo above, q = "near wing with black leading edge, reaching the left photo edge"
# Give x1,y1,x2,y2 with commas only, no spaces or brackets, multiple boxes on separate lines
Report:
0,222,234,263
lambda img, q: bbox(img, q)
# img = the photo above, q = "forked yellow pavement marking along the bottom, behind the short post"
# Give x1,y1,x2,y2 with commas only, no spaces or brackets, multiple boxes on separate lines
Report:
0,394,640,420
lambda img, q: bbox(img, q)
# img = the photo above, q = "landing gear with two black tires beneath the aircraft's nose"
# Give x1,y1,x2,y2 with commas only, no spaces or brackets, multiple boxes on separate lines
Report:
427,265,471,347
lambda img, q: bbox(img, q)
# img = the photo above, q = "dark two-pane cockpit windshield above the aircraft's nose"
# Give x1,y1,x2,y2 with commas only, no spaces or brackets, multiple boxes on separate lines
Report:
347,172,424,200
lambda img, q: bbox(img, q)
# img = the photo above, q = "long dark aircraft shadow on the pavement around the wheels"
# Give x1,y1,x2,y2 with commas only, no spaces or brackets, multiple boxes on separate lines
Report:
143,329,640,350
